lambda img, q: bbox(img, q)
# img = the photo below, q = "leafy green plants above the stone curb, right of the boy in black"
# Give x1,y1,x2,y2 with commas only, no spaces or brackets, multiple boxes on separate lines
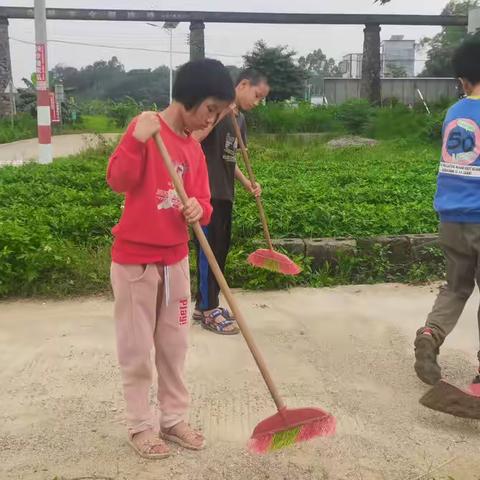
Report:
234,135,439,241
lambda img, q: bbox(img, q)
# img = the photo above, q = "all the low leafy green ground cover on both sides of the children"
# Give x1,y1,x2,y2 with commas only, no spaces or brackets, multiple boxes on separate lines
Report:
0,138,440,297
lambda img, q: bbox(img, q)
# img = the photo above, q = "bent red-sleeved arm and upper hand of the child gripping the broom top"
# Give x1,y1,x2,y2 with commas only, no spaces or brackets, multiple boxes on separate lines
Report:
107,112,160,193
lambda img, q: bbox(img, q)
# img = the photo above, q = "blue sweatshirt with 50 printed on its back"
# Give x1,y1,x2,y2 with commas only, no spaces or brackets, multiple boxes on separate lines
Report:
434,97,480,223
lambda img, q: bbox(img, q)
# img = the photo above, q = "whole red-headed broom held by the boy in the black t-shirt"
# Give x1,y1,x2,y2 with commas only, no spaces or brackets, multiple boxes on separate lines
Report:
231,112,302,275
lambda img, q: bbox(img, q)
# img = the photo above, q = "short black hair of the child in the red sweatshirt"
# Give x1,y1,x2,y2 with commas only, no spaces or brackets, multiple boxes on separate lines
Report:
172,58,235,110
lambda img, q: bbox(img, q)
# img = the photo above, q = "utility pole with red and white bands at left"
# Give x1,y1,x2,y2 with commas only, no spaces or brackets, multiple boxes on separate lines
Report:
34,0,52,163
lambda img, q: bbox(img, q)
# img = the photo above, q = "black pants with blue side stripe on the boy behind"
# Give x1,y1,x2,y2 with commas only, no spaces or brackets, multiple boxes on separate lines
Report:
196,199,233,311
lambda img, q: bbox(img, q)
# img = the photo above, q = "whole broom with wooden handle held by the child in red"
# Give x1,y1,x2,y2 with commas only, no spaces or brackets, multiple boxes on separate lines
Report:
155,134,335,453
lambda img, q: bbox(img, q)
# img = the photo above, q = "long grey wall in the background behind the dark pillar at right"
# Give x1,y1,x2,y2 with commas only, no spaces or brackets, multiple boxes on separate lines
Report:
325,78,458,105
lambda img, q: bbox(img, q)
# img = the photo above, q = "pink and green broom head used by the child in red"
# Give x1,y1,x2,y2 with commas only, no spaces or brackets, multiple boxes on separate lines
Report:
248,407,336,453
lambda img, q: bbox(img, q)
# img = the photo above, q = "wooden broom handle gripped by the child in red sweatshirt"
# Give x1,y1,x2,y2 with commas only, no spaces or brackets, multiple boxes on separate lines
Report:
154,133,285,410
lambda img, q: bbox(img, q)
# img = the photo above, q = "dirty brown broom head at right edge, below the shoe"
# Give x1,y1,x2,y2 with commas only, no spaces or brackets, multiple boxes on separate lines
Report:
420,380,480,420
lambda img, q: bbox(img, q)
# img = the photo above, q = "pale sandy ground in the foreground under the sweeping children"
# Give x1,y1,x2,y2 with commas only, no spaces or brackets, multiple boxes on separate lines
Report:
0,285,480,480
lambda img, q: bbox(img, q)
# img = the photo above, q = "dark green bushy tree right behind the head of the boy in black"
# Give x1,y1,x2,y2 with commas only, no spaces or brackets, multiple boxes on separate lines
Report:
243,40,308,100
